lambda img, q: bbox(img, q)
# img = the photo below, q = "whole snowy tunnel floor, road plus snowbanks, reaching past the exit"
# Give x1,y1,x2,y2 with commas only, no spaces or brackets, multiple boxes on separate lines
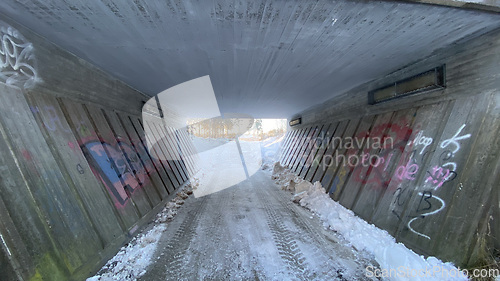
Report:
88,136,467,281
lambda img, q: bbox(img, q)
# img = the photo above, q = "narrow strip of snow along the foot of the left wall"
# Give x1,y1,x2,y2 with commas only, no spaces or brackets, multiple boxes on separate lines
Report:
87,185,193,281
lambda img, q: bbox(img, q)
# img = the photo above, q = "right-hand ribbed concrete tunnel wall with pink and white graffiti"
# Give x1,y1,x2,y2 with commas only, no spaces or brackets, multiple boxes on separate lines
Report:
281,28,500,266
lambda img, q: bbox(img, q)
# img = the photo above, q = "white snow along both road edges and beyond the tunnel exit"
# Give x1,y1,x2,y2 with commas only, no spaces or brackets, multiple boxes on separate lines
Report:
87,136,476,281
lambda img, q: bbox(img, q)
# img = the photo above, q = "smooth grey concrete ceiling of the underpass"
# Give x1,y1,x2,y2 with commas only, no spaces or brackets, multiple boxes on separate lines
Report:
0,0,500,117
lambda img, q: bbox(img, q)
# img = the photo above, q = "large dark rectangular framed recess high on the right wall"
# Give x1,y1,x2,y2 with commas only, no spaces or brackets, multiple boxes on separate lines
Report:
368,65,446,104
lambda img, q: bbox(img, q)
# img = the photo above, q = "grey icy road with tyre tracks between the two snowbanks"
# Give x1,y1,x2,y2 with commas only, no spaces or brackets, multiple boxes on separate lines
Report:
140,168,372,280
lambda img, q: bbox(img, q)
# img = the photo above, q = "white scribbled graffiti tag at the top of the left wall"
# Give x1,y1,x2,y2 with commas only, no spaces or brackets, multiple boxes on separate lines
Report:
0,21,39,88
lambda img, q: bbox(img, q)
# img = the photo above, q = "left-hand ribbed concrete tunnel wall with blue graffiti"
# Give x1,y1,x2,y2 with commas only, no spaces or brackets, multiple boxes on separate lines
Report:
0,12,195,280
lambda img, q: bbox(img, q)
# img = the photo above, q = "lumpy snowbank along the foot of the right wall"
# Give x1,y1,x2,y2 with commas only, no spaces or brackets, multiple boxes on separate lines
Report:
273,163,468,280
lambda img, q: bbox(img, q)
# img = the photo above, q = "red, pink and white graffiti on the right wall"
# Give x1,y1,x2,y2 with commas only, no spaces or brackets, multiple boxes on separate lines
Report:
312,117,471,239
